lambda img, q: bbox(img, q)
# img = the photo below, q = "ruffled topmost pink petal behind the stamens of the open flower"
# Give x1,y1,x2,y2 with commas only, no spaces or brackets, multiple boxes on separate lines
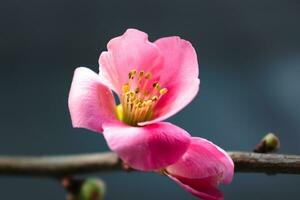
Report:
99,29,162,95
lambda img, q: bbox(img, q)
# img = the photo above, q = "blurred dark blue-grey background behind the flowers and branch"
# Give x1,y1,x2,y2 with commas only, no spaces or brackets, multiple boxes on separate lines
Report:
0,0,300,200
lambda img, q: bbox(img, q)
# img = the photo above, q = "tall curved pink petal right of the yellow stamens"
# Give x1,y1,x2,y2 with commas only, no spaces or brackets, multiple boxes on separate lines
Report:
139,36,200,125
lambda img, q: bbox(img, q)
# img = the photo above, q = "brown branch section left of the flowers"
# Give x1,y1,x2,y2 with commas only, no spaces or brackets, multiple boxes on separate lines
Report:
0,152,122,177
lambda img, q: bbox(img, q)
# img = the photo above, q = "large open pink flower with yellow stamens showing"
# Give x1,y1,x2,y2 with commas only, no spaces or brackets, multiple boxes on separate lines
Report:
69,29,200,170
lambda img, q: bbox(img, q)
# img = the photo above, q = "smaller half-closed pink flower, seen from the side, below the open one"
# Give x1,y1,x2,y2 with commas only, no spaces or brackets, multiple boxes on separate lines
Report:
163,137,234,200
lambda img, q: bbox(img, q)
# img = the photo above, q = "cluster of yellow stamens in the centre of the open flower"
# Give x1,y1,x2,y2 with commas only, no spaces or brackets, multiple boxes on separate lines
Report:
117,70,168,126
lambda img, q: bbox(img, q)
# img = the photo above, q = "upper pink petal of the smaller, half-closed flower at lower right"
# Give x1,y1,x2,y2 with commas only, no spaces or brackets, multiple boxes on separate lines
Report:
167,137,234,184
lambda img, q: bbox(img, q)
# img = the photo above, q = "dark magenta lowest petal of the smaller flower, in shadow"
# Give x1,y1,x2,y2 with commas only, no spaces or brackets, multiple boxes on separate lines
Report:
168,175,224,200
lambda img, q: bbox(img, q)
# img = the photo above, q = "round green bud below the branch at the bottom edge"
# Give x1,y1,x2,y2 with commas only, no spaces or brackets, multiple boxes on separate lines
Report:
79,178,106,200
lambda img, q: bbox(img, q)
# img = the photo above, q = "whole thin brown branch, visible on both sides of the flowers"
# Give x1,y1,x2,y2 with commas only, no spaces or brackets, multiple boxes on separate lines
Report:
0,152,300,177
